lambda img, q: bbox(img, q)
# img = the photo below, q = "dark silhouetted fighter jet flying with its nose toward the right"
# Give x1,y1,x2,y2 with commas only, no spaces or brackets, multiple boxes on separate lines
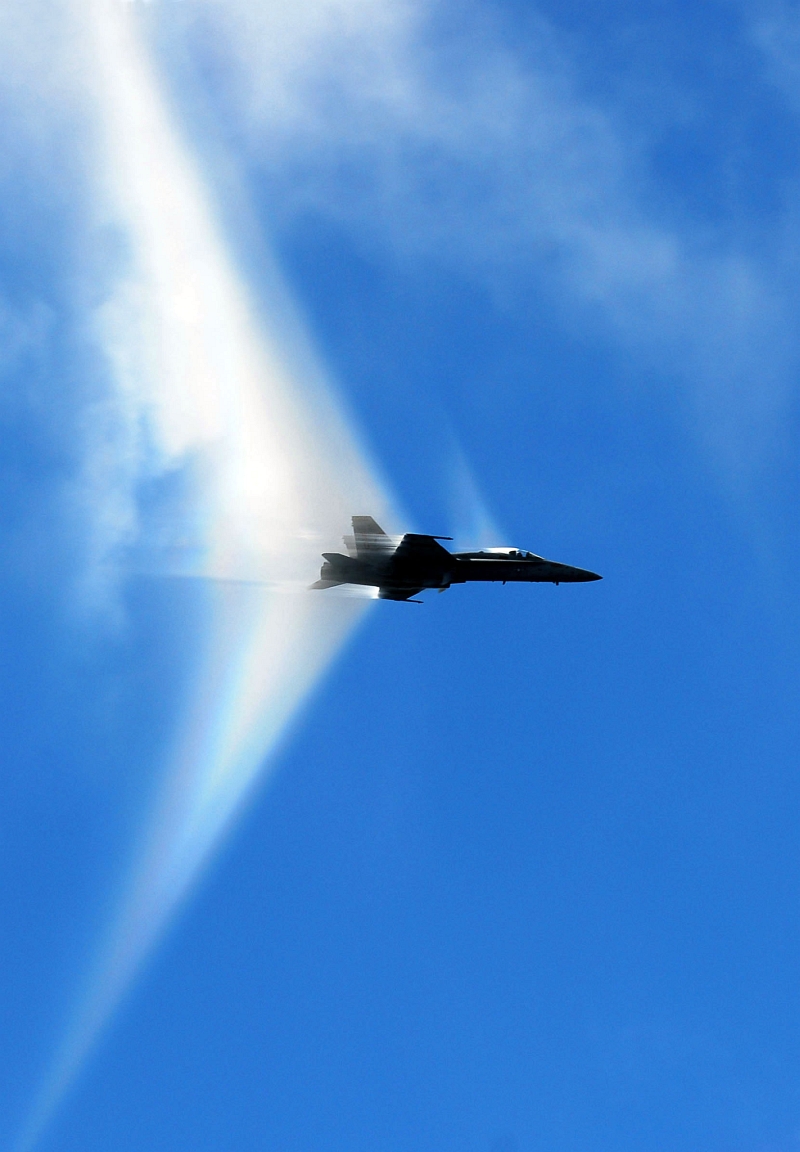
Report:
311,516,602,604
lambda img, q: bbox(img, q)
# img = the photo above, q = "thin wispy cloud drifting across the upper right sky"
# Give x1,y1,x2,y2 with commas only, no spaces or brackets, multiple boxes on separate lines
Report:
162,0,798,484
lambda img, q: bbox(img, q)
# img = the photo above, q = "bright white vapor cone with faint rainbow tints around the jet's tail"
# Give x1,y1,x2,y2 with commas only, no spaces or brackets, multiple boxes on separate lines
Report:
17,0,387,1152
